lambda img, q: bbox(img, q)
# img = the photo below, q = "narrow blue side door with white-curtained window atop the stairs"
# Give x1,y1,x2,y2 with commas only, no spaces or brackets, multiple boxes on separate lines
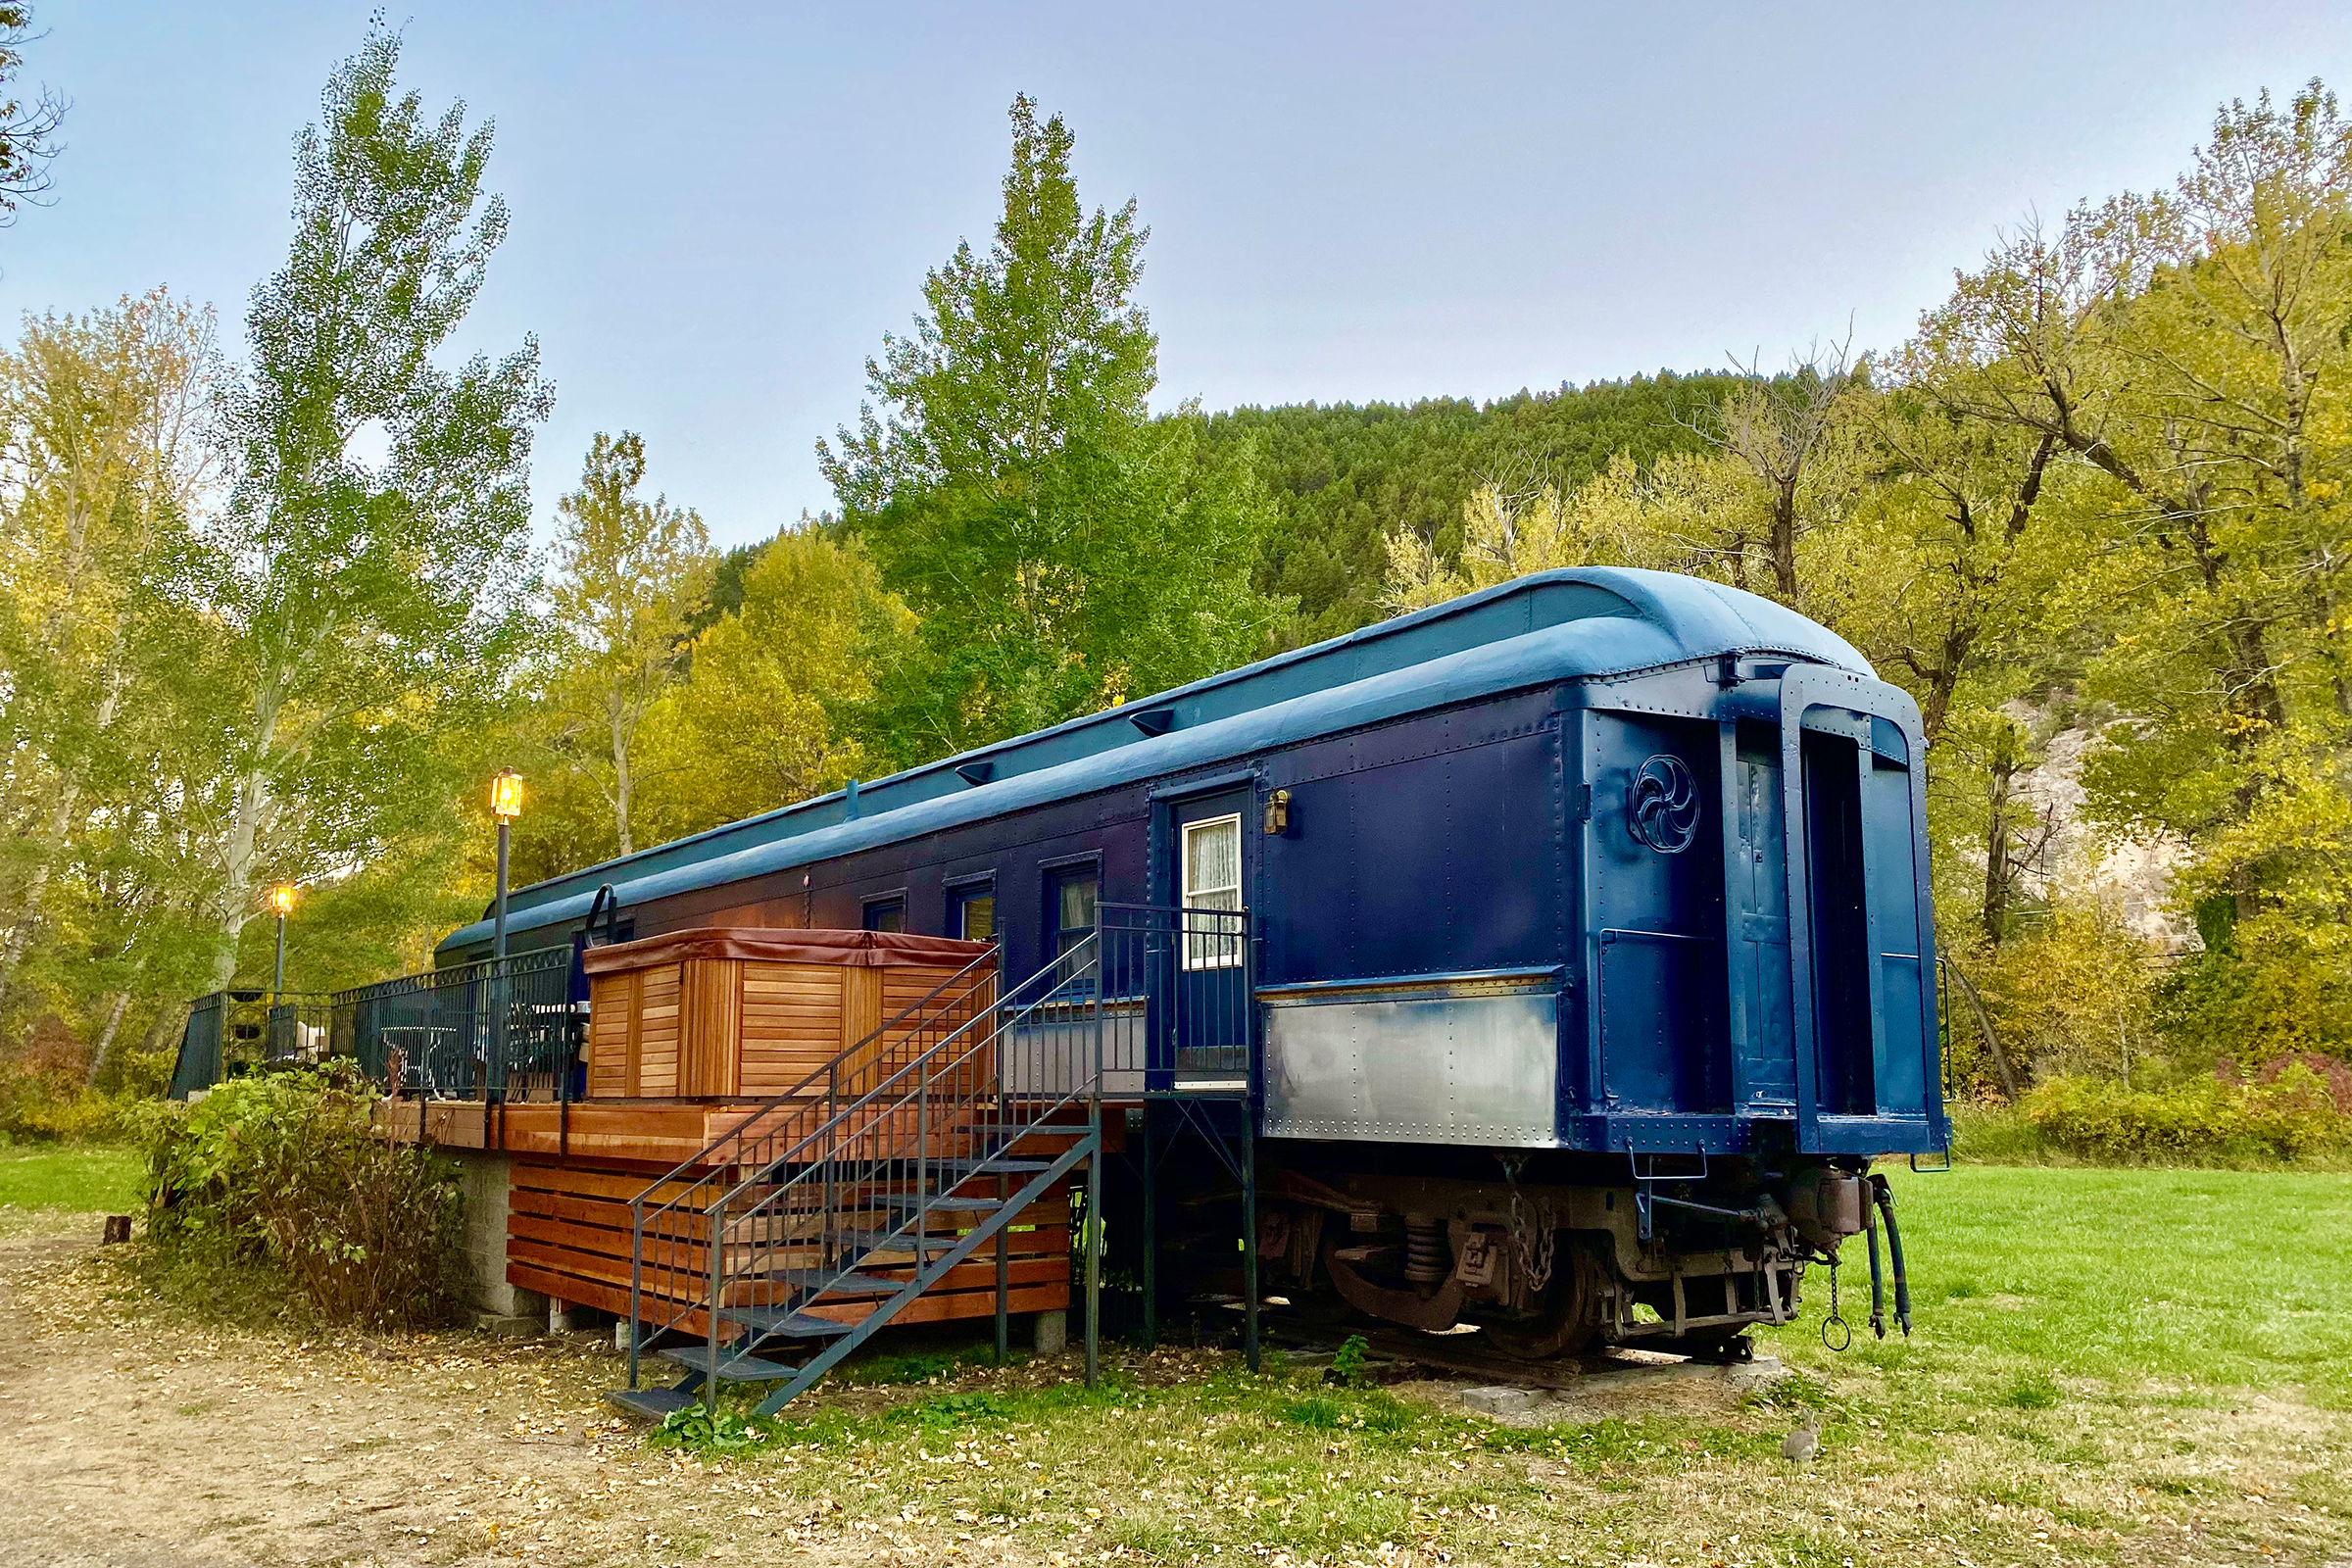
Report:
1152,790,1253,1089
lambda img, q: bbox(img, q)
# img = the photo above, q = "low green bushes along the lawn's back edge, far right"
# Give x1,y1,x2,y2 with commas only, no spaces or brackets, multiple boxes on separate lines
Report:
2025,1062,2352,1163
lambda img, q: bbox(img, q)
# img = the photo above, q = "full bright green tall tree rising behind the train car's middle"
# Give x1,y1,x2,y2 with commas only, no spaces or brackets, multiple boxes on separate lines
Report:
818,96,1280,753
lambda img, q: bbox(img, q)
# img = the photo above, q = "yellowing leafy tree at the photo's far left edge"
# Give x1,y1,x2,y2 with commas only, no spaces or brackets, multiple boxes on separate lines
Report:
0,289,219,1025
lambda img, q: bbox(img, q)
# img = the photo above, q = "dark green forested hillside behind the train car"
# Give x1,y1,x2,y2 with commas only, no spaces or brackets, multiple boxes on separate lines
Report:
1209,371,1736,647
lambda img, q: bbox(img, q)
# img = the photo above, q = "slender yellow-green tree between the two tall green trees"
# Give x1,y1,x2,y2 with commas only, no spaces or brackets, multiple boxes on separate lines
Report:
555,430,715,856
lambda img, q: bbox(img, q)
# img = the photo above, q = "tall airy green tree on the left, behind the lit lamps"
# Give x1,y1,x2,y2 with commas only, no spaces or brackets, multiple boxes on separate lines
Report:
195,28,553,983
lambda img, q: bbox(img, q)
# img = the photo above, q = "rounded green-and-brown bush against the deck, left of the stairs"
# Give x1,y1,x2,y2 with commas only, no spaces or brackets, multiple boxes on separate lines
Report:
143,1072,461,1326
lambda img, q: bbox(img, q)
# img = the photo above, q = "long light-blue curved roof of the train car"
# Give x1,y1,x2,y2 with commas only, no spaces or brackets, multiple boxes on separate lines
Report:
437,566,1872,956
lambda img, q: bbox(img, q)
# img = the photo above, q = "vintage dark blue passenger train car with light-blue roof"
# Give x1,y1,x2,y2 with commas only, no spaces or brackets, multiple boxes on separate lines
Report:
440,569,1947,1354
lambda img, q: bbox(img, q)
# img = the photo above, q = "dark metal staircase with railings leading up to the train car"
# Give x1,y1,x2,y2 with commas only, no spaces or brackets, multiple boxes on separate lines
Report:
607,931,1103,1420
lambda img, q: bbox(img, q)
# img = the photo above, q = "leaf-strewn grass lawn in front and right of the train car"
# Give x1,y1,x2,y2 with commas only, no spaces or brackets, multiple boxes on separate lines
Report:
630,1166,2352,1568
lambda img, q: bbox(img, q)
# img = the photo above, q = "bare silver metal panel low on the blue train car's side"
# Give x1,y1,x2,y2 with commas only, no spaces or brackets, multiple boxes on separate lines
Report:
1265,990,1559,1150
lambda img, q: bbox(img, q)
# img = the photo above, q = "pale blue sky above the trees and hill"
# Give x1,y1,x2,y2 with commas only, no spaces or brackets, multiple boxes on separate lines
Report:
0,0,2352,543
